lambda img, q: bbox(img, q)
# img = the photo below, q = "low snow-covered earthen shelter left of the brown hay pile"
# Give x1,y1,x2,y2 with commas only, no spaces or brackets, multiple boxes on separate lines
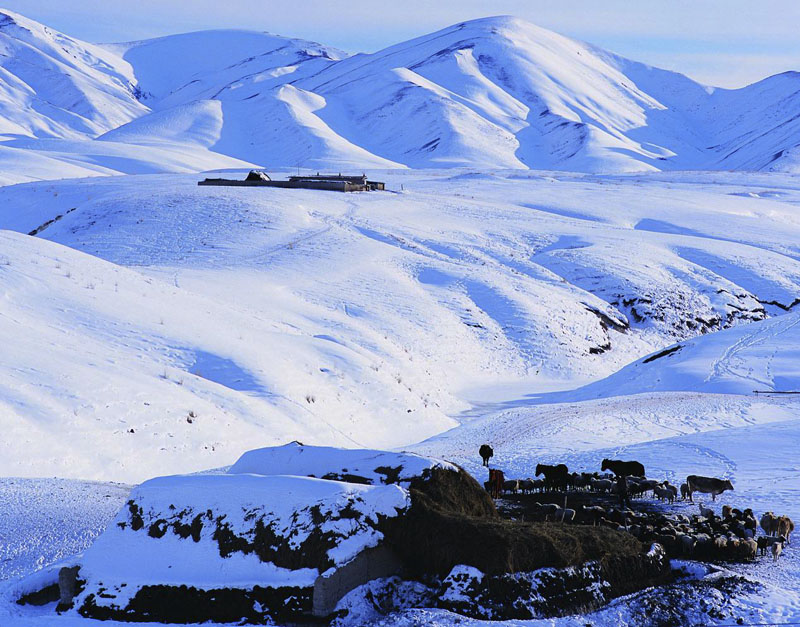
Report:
54,444,432,622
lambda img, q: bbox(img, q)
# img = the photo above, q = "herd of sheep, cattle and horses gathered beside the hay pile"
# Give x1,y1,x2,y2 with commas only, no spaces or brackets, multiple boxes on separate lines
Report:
481,445,794,561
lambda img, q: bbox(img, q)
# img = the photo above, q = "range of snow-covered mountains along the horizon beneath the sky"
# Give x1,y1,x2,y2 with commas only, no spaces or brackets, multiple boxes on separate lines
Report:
0,12,800,182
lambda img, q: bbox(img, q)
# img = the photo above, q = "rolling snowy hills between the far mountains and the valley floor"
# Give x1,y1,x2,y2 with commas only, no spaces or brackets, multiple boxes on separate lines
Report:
0,171,800,480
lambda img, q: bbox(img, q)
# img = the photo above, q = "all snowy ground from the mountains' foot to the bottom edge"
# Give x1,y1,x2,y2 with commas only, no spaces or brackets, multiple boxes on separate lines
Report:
0,170,800,625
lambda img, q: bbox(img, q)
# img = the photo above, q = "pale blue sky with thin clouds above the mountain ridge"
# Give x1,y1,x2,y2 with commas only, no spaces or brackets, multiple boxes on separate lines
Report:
3,0,800,87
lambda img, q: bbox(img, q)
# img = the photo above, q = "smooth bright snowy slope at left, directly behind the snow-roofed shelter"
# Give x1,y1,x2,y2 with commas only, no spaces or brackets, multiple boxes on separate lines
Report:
0,231,454,481
